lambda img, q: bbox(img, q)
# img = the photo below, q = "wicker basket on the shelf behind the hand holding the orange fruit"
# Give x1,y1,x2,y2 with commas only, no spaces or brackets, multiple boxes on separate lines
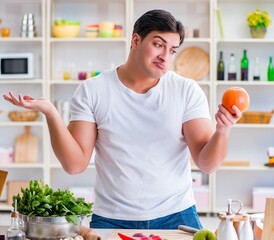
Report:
237,112,273,124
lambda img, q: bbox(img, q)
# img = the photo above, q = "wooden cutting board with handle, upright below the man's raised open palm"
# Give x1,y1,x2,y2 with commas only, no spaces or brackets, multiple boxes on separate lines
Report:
14,126,38,163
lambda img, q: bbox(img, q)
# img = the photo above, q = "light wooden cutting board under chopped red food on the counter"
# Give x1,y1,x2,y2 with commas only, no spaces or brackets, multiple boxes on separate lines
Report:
108,229,193,240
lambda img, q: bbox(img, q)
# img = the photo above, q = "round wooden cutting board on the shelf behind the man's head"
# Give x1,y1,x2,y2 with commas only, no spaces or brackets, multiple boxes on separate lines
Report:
175,47,209,80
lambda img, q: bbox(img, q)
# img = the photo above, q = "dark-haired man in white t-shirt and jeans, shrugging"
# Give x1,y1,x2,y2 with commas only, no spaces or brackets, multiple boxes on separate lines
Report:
4,10,241,229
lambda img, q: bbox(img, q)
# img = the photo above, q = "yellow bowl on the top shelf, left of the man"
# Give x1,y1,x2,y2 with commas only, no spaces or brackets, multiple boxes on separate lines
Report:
51,25,80,38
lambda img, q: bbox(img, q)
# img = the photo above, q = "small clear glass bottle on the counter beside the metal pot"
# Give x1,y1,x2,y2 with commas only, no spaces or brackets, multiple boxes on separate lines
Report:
7,200,26,240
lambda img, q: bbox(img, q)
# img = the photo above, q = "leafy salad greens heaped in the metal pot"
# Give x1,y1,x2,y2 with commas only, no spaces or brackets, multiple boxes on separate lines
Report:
13,180,92,224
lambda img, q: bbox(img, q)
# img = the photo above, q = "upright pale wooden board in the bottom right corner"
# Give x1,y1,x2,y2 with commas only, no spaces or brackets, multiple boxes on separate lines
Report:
262,198,274,240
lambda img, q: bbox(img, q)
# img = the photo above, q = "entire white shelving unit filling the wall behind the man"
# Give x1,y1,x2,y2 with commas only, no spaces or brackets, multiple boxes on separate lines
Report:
0,0,274,212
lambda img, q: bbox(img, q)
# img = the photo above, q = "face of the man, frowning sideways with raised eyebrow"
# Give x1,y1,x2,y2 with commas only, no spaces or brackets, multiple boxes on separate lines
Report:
132,31,180,79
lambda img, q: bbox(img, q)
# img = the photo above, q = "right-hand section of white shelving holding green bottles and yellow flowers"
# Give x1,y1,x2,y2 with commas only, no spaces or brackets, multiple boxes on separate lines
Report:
212,0,274,212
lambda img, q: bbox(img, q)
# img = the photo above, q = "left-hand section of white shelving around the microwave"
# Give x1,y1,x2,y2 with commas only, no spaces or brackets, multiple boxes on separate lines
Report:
0,0,48,210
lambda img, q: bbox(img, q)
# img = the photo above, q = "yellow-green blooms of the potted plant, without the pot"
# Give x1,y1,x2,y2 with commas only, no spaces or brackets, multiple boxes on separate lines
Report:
247,9,272,28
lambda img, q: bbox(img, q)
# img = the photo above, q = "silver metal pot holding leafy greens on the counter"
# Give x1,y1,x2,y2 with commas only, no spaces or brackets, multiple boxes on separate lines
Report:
19,214,84,240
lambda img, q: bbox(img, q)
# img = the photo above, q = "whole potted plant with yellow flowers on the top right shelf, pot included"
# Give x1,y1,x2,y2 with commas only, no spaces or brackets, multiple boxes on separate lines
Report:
247,9,272,38
